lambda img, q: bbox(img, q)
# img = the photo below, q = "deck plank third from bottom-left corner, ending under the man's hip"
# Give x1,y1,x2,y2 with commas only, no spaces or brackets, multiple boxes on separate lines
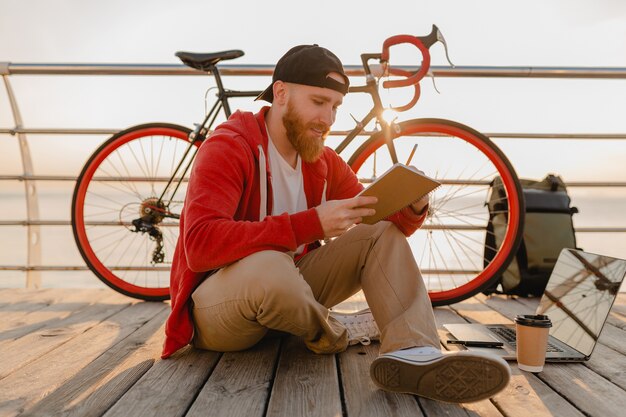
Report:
105,346,221,417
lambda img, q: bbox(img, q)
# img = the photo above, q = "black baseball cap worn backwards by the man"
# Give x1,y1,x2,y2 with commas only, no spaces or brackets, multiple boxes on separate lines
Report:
256,44,350,103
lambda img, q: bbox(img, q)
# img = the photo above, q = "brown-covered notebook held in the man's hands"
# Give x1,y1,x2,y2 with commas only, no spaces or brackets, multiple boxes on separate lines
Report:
359,163,441,224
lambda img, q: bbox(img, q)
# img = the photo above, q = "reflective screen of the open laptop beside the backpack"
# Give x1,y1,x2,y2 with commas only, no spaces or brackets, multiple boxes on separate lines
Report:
537,249,626,356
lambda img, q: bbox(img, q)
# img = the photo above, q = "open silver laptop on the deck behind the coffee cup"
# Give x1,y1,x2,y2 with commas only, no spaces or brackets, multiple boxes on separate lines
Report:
444,249,626,362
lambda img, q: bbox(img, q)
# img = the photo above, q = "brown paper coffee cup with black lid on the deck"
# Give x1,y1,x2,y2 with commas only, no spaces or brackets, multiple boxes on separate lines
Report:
515,314,552,372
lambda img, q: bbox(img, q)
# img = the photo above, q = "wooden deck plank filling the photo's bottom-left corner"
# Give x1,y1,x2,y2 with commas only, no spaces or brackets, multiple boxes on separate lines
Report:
0,299,161,416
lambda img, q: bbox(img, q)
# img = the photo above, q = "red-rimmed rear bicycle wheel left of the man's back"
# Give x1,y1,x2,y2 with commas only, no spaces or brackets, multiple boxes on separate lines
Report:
72,123,194,301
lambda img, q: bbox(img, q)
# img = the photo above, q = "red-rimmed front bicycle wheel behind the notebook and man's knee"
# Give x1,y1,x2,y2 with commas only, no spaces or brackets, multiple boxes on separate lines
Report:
348,119,524,306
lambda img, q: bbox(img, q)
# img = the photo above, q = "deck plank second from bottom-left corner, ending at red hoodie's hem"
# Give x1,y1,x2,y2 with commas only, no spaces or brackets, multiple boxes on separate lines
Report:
25,304,169,417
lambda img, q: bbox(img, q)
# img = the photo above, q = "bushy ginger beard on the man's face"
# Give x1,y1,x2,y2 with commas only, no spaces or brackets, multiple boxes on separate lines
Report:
283,103,330,162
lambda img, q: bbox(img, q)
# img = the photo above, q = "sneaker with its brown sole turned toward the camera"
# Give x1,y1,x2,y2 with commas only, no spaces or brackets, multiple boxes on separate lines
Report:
370,351,511,403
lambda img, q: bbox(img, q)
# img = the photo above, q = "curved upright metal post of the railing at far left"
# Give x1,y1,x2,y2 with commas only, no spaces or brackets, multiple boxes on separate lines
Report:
2,73,41,288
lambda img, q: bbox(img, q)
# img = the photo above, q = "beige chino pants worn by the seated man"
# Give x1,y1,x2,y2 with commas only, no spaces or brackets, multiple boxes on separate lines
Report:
192,221,439,353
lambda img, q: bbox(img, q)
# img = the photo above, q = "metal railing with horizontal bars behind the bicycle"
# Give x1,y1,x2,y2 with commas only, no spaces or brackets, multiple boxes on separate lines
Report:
0,62,626,287
